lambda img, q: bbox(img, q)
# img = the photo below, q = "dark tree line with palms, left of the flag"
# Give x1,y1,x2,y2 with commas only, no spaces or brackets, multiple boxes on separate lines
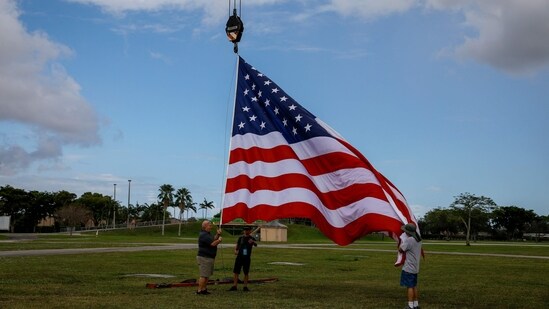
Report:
0,184,214,233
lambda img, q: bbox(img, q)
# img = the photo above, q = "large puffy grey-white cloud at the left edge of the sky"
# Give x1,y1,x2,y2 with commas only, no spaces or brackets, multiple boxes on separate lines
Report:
0,1,100,174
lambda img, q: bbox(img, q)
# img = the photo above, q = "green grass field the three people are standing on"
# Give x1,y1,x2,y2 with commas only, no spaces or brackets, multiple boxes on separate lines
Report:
0,225,549,308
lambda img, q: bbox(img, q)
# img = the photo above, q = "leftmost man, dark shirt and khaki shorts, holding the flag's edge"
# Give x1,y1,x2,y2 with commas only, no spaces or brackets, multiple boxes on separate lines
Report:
196,220,222,295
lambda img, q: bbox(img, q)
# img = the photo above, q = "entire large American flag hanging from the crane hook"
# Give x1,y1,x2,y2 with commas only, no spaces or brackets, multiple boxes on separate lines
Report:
221,56,416,245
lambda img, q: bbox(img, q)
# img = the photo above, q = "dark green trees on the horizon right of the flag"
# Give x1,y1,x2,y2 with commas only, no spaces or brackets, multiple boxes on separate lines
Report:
418,193,549,245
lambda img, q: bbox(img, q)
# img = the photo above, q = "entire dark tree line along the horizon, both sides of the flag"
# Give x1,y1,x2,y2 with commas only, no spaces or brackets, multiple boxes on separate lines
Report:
0,184,549,241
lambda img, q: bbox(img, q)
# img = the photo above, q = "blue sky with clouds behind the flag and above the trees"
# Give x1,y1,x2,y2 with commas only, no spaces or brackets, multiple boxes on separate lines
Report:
0,0,549,218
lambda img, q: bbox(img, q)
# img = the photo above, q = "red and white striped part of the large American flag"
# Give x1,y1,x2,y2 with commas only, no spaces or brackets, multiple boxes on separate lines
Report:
222,119,415,245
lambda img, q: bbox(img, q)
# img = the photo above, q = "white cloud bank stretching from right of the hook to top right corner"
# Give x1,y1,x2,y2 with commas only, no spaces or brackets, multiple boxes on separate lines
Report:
308,0,549,74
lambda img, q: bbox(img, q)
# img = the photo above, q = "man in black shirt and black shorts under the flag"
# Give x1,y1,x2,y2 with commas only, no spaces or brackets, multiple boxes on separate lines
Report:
229,226,257,292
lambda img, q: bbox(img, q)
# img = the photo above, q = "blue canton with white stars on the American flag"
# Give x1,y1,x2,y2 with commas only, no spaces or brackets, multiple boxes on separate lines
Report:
232,57,331,143
